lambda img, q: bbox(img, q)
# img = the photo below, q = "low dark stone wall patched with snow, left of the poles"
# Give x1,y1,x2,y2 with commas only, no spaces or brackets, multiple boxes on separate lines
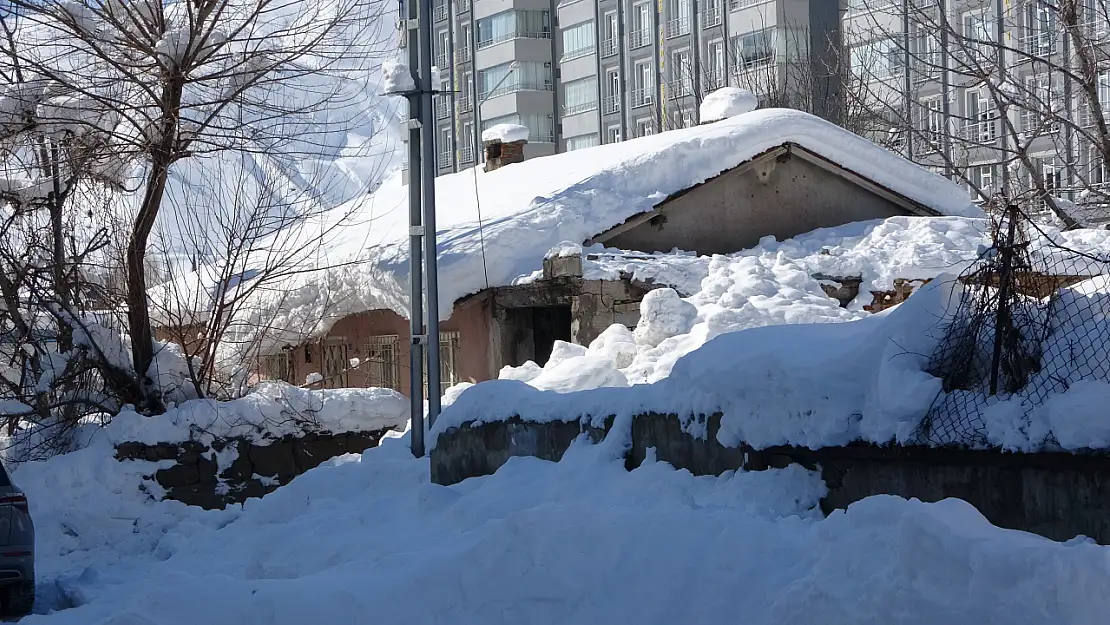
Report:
115,430,387,510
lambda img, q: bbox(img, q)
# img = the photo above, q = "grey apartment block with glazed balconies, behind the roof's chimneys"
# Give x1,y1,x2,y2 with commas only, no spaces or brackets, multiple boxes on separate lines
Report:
424,0,840,174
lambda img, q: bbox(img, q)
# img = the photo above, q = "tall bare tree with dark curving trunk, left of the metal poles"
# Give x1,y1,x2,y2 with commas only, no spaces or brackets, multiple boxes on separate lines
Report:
2,0,392,412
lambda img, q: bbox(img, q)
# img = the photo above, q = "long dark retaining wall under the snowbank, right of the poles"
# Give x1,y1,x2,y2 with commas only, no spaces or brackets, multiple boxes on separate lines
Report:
431,414,1110,544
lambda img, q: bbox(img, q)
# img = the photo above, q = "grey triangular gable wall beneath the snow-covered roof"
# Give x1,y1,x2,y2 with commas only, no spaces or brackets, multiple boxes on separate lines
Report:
598,147,911,254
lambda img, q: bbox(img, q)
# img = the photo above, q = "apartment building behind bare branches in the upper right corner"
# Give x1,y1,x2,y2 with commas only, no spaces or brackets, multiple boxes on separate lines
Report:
842,0,1110,215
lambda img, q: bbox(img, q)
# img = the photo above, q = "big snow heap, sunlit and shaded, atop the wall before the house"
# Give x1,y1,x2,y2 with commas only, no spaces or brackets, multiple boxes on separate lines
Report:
432,218,1110,450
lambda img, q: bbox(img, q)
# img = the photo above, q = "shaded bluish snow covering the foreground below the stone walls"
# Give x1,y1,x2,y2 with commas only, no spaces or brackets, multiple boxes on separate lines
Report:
14,440,1110,625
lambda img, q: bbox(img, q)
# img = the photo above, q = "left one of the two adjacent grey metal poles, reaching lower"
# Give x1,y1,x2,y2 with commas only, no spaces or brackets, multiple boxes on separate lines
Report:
405,0,431,457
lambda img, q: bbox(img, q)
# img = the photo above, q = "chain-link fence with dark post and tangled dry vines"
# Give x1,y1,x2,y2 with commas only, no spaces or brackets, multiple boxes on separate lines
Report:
912,205,1110,447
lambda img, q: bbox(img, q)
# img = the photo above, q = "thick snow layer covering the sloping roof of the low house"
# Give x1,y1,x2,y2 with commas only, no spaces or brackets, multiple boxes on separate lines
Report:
155,109,981,359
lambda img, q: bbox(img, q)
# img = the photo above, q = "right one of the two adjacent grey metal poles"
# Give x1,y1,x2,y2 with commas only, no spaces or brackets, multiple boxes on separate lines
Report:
418,0,440,425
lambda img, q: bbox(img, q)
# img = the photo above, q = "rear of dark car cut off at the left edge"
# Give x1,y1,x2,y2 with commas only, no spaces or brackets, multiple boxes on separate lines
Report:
0,463,34,617
